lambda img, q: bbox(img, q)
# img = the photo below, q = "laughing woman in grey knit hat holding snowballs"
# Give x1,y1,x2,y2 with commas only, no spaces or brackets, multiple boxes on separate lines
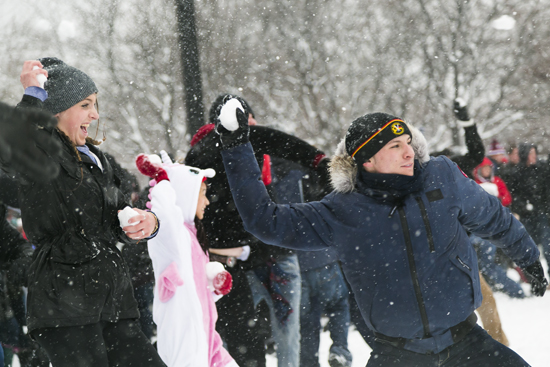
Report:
10,58,164,367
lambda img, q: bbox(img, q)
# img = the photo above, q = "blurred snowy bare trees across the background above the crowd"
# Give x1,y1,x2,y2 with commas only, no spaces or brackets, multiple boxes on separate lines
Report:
0,0,550,167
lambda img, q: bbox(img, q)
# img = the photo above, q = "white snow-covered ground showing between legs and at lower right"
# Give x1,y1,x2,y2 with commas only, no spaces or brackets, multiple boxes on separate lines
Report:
267,286,550,367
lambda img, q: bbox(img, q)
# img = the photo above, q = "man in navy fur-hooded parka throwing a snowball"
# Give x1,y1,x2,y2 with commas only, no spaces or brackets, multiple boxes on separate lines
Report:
217,100,548,367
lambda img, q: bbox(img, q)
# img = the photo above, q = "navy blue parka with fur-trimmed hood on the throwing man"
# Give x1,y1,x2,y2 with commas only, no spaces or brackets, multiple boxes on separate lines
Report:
222,124,539,353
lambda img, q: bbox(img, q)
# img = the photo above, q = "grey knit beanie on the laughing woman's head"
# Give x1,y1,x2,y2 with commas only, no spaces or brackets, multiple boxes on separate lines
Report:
39,57,97,115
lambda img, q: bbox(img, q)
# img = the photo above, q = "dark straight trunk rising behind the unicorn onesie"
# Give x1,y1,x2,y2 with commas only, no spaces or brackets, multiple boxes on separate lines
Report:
175,0,204,135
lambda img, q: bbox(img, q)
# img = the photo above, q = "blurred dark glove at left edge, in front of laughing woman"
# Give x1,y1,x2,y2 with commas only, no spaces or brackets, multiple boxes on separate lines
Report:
0,103,61,180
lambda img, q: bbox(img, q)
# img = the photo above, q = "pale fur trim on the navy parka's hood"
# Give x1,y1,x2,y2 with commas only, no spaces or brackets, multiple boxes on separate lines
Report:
329,122,430,193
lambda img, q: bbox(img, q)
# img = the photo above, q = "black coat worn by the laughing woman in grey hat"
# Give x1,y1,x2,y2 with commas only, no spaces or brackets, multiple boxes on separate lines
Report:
8,96,139,331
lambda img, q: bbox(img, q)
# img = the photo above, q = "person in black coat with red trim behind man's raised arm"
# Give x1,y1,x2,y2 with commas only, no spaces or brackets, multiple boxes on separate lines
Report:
185,94,326,366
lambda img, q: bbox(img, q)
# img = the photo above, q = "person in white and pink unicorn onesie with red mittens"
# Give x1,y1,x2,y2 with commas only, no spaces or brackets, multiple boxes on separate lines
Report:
136,152,238,367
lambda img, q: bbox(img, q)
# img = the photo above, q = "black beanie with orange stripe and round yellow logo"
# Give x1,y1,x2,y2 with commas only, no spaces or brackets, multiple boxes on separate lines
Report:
346,112,412,164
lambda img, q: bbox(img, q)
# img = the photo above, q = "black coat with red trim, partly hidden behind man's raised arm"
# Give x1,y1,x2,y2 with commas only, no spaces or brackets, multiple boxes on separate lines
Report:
185,124,324,267
